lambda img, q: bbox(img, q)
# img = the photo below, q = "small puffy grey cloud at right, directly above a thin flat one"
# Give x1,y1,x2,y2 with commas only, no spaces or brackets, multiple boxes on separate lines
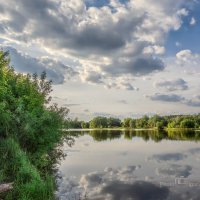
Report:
155,78,188,91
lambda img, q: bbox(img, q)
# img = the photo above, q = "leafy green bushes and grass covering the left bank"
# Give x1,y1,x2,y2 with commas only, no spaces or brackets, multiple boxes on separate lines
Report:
0,51,68,200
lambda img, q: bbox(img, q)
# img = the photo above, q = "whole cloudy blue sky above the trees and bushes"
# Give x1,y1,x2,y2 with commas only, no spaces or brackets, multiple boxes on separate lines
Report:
0,0,200,120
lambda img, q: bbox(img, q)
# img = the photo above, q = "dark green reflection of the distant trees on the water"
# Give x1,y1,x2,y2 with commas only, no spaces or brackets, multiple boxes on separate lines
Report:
65,129,200,143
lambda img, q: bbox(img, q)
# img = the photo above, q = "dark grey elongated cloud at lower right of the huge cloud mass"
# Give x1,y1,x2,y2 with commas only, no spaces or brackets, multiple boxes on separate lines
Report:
103,56,165,76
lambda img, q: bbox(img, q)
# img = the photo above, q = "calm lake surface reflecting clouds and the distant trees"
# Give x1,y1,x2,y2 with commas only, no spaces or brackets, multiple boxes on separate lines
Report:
57,131,200,200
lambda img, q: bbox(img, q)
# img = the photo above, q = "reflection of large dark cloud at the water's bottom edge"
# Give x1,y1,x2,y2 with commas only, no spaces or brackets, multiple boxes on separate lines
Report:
57,166,169,200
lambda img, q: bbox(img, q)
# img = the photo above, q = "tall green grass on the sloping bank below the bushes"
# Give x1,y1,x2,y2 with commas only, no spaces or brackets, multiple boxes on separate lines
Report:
0,138,55,200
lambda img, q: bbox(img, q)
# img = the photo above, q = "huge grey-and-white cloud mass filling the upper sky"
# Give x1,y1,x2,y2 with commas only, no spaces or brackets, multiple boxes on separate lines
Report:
0,0,191,84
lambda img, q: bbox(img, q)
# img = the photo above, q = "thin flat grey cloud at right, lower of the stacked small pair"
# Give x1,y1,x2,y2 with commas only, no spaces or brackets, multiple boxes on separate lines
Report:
147,93,185,102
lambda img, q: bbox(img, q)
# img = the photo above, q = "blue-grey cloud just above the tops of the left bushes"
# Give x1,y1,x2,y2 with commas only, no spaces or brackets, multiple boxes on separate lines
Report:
4,47,77,84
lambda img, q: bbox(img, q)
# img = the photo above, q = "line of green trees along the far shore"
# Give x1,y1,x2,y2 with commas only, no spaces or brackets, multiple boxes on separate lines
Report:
65,114,200,129
